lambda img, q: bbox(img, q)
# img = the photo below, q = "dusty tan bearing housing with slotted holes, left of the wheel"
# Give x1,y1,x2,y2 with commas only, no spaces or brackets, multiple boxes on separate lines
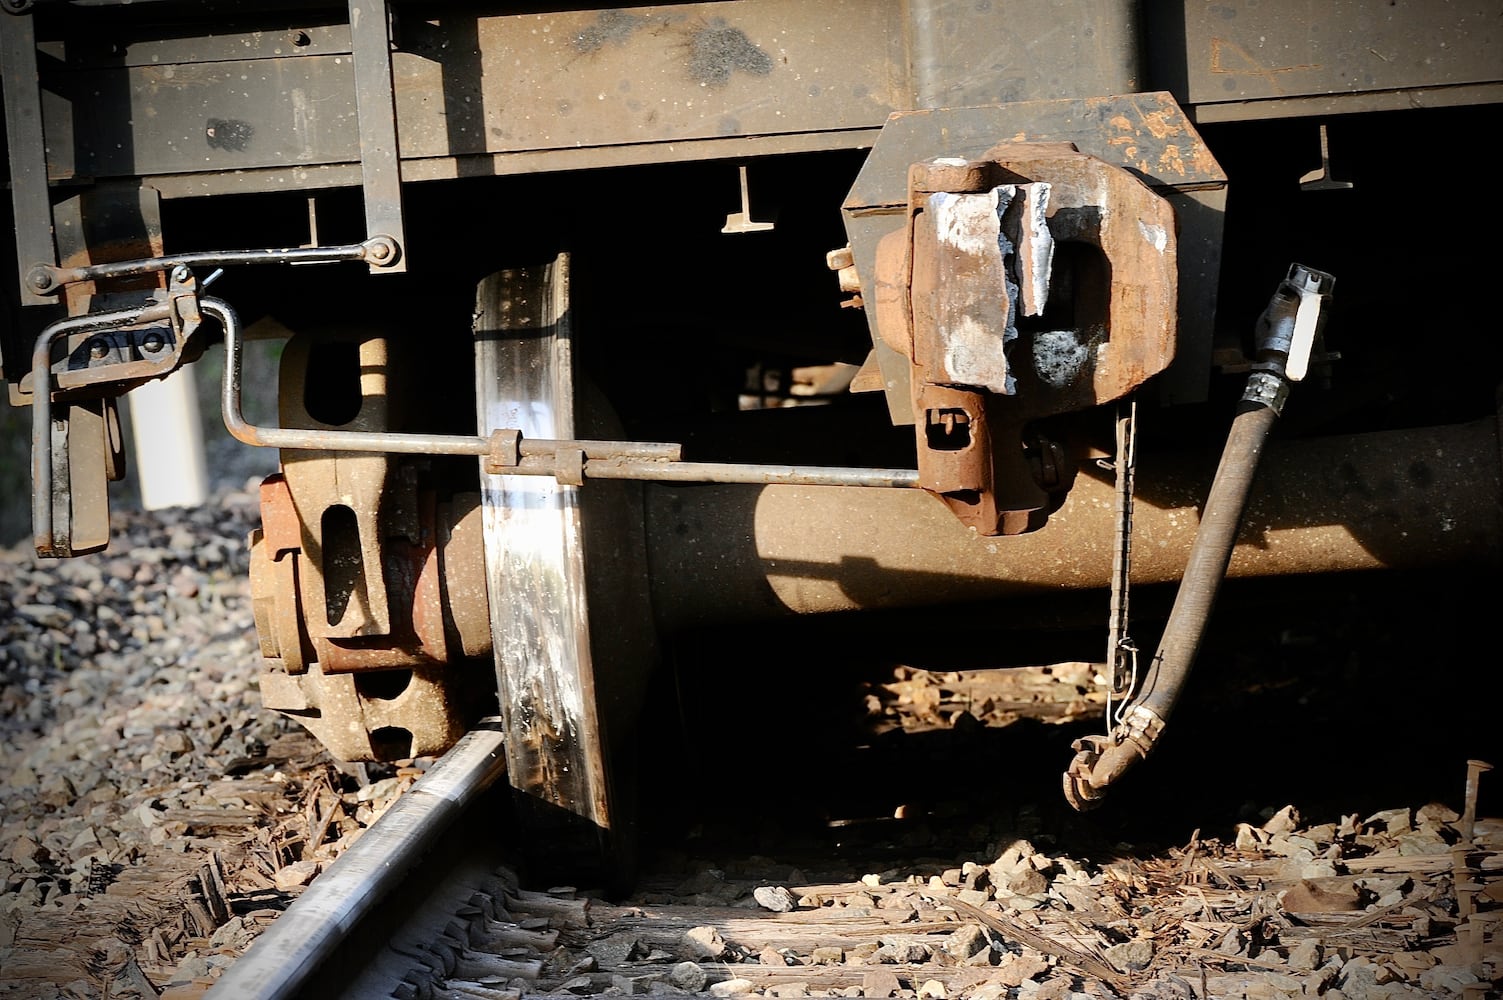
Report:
251,335,490,761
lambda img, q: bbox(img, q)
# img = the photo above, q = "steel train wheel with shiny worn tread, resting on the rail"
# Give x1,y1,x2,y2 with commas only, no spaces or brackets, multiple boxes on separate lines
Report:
473,256,655,886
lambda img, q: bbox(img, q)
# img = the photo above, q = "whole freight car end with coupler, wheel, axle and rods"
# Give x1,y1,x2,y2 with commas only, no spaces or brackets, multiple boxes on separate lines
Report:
0,0,1503,866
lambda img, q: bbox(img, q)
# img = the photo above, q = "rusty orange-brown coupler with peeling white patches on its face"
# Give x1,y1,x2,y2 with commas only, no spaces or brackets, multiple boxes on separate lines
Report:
875,143,1178,535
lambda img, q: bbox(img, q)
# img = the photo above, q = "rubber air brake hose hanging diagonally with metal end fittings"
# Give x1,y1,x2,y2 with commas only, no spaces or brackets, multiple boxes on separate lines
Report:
1064,265,1335,811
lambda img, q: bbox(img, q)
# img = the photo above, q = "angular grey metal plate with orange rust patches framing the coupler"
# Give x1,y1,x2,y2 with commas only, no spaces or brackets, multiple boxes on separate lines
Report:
843,93,1226,423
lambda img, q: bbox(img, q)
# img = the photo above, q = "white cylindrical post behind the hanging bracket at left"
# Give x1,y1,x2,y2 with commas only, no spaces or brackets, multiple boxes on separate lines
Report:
126,365,209,510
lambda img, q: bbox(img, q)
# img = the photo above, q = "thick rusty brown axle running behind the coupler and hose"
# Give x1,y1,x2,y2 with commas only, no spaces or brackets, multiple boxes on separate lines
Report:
648,418,1503,626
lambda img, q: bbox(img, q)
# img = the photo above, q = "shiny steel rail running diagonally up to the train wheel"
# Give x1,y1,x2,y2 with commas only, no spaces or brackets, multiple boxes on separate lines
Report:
207,719,507,1000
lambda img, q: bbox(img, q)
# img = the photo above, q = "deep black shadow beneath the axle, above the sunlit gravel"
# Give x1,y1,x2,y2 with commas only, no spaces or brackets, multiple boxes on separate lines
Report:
643,574,1503,863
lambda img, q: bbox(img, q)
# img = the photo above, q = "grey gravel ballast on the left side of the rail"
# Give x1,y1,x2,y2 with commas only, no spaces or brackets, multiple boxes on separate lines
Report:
0,490,418,1000
